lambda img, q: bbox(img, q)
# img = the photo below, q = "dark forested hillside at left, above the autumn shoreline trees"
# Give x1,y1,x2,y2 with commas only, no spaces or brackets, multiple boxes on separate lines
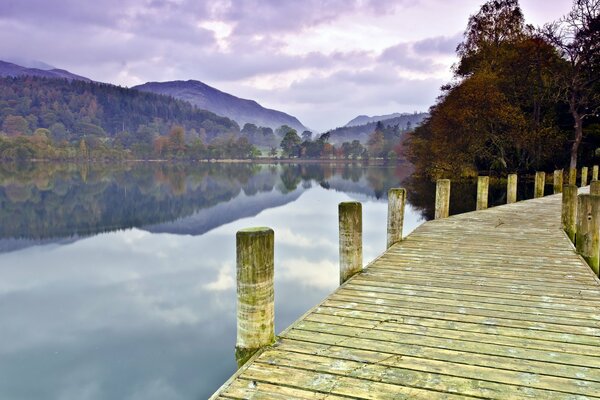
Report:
0,76,239,142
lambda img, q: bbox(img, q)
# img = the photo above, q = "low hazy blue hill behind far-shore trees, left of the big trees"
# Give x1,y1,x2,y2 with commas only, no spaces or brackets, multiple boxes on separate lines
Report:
329,113,429,145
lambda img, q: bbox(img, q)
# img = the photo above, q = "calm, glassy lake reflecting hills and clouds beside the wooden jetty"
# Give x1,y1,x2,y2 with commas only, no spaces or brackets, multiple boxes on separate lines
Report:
0,163,529,400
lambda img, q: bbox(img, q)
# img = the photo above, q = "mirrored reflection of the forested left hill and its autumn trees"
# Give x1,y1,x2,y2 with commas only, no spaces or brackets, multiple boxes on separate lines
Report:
0,164,268,239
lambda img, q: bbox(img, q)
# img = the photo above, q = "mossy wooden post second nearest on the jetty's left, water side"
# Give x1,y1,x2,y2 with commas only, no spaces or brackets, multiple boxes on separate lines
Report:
338,201,362,285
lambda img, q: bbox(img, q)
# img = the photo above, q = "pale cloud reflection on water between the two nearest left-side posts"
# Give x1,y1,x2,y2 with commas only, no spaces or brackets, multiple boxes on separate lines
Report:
276,259,339,290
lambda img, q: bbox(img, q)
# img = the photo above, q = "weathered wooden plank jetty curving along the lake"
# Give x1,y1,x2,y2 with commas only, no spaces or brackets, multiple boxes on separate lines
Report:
212,174,600,399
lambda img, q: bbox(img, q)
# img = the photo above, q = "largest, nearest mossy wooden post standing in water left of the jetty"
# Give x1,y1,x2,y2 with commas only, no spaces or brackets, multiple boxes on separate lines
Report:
235,228,275,367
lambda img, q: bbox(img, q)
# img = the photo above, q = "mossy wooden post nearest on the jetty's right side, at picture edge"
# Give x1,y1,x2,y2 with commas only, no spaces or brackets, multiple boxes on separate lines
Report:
575,194,600,275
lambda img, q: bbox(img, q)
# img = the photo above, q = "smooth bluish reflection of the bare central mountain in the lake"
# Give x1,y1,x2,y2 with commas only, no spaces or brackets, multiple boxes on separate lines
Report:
144,189,303,236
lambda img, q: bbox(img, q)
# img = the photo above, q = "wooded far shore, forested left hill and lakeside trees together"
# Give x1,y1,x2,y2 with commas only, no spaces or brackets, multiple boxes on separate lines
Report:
0,77,410,160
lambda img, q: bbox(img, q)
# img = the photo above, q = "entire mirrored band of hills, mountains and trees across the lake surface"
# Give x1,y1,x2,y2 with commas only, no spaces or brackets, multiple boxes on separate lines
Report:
0,163,410,244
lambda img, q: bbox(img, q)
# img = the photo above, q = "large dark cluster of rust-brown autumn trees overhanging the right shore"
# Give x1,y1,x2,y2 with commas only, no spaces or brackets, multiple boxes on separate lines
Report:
405,0,600,177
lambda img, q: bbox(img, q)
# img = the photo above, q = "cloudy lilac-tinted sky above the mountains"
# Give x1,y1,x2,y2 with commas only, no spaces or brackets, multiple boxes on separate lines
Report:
0,0,571,131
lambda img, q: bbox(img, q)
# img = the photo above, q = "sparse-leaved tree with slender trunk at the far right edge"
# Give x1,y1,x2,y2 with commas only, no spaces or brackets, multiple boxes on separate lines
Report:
544,0,600,169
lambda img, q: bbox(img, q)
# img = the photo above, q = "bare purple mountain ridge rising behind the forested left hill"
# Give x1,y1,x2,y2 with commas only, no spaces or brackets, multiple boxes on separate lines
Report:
133,80,307,133
